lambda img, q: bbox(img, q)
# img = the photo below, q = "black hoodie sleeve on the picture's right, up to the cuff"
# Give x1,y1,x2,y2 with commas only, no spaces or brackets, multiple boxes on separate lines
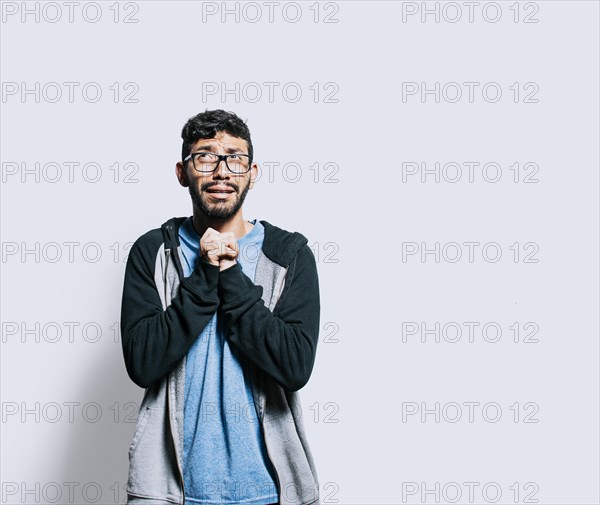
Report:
218,244,320,391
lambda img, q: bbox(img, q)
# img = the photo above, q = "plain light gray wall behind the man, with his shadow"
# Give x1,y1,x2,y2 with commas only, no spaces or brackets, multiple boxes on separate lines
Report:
1,1,600,504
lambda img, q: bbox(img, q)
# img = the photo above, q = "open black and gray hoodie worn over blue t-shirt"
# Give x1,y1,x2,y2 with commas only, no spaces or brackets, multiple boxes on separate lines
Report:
121,217,320,505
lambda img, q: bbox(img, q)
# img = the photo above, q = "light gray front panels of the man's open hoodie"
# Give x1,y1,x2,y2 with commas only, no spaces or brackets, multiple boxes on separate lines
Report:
127,238,319,505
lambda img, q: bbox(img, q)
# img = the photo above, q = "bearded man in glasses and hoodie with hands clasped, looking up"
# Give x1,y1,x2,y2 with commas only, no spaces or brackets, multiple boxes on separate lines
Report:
121,110,320,505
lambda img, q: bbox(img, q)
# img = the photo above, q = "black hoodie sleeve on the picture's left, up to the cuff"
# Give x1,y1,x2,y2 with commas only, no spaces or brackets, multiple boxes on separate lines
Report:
121,236,219,388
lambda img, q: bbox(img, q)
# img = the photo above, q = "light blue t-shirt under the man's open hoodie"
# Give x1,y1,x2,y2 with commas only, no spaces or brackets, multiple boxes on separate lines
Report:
179,217,279,505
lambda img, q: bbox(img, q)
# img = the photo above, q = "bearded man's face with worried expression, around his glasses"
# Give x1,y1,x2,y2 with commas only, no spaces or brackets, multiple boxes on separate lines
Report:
177,131,258,219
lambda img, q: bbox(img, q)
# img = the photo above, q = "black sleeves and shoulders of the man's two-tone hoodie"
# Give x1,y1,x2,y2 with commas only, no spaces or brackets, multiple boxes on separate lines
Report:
121,217,320,391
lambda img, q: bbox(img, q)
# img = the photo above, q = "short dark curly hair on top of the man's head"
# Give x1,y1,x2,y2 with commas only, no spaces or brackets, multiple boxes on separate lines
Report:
181,109,254,160
